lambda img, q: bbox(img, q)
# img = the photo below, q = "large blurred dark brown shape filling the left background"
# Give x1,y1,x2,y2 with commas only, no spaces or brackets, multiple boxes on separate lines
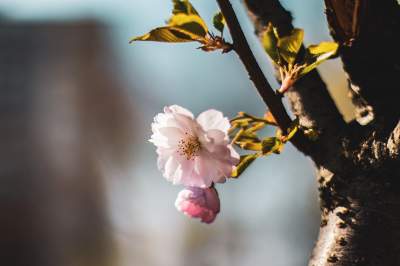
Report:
0,22,131,266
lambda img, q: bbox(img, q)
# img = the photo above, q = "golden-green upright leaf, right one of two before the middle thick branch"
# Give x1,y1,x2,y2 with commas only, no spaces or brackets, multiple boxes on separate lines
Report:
278,29,304,65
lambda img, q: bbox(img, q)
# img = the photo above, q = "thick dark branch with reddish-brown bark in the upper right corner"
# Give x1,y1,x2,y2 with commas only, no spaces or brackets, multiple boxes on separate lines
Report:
325,0,400,130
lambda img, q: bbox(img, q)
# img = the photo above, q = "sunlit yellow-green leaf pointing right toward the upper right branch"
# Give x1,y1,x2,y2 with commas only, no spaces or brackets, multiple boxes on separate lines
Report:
299,42,339,76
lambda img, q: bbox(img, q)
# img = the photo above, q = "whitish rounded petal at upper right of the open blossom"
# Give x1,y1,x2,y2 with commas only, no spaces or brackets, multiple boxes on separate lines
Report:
197,109,231,133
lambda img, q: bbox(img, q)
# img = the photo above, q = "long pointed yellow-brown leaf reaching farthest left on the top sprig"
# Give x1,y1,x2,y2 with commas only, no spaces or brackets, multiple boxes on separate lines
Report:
129,26,203,43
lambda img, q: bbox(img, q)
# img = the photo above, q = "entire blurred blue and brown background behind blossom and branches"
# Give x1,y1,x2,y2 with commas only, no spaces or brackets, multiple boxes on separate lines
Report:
0,0,352,266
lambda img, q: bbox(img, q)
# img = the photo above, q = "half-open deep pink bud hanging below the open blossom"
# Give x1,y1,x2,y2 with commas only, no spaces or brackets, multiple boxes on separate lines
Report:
175,187,220,224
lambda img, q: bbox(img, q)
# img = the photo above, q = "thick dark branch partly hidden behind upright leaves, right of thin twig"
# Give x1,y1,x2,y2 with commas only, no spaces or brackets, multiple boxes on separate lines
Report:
245,0,346,134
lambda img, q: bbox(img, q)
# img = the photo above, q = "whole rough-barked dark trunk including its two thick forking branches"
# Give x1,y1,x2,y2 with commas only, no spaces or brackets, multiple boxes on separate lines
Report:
241,0,400,266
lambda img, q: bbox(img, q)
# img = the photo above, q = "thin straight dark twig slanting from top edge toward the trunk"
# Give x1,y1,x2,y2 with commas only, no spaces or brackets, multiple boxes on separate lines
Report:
217,0,292,132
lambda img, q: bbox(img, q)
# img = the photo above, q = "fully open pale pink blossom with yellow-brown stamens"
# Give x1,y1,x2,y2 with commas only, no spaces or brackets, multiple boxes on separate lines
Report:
150,105,239,188
